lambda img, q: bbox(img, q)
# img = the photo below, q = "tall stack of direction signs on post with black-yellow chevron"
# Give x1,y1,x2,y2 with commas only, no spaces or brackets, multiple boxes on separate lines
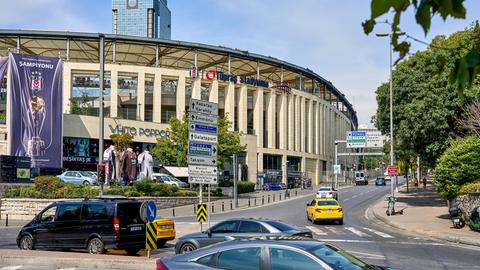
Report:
188,99,218,230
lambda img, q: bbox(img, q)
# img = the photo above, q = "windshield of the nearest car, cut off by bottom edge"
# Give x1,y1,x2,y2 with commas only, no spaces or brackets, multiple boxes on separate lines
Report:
308,244,373,270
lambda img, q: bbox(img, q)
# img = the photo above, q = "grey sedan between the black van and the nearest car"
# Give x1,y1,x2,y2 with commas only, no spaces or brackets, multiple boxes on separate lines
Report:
175,218,312,254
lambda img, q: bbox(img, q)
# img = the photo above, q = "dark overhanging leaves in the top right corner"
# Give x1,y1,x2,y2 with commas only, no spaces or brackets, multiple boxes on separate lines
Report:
362,0,480,92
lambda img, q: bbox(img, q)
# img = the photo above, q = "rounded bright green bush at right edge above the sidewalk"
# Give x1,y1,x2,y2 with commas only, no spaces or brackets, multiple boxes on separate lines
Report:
435,136,480,199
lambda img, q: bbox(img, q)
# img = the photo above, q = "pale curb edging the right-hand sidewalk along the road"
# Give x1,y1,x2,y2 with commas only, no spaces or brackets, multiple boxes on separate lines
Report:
370,197,480,247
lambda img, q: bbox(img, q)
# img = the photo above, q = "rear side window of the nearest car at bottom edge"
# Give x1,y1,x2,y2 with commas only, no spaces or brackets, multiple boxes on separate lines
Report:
217,247,261,270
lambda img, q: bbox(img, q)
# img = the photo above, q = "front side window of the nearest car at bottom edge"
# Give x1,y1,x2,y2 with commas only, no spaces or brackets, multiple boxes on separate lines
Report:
269,248,324,270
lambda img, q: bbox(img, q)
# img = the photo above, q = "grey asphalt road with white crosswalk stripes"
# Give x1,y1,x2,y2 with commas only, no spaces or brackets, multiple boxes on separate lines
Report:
0,180,480,269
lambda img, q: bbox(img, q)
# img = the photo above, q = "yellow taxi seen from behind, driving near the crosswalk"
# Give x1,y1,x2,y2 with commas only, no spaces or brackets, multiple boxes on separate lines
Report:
307,198,343,225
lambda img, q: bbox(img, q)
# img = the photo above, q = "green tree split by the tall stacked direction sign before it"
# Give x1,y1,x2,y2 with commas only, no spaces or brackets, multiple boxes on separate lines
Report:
152,111,246,167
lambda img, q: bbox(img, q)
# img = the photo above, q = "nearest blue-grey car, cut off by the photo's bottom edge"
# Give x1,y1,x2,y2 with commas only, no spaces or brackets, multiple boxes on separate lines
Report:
157,237,392,270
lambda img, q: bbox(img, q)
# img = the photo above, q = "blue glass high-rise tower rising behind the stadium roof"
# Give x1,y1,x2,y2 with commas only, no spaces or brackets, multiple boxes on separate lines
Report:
112,0,171,39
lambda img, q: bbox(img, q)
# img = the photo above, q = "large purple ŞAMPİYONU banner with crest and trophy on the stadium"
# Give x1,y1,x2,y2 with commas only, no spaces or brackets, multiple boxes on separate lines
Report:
9,54,63,168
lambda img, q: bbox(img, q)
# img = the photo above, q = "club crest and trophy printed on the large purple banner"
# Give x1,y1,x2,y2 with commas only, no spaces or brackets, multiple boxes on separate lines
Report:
27,72,45,165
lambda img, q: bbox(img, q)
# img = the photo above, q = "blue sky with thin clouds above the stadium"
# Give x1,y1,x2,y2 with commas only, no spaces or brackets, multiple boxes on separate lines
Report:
0,0,480,126
